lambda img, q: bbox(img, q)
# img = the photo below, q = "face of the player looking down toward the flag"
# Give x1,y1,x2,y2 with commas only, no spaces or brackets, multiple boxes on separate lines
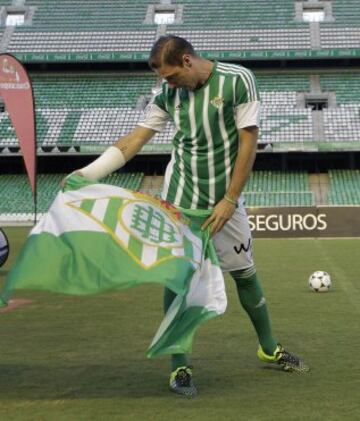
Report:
155,59,198,91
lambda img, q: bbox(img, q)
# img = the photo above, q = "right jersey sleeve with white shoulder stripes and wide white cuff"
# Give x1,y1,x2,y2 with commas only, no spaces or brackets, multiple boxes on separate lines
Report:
234,68,260,129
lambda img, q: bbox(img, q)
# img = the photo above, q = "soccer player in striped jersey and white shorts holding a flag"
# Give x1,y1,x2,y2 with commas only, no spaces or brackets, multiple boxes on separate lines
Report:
67,35,309,396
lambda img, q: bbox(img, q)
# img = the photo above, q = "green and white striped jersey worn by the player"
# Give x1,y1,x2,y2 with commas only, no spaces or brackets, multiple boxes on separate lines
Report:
139,62,260,209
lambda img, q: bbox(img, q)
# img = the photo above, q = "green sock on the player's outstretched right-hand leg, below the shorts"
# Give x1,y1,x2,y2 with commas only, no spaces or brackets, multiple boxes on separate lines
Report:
230,268,277,355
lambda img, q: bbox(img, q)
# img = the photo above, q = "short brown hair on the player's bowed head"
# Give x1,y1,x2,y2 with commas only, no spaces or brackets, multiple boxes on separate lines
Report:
149,35,196,69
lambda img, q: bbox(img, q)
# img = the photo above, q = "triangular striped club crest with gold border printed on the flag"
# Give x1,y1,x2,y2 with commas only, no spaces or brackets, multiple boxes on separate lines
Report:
66,193,200,269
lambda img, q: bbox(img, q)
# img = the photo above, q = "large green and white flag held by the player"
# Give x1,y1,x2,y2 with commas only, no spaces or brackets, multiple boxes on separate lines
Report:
1,176,227,357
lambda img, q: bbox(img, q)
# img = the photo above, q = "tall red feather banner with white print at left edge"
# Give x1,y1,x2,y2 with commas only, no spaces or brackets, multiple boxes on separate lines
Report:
0,54,36,200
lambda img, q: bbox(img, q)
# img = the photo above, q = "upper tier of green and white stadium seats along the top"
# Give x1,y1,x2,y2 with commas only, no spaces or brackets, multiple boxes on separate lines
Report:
0,0,360,62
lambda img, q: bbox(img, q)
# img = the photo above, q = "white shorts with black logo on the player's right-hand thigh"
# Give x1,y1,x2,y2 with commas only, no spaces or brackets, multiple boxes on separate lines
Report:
213,204,254,272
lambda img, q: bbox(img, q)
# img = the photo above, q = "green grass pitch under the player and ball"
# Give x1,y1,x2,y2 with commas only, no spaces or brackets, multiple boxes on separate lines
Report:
0,228,360,421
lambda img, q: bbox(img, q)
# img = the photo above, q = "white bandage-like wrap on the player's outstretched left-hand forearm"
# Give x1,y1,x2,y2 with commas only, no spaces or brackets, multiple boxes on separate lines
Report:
79,146,126,181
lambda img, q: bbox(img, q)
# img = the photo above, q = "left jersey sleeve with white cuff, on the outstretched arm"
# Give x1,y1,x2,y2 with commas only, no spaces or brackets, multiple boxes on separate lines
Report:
138,85,170,132
